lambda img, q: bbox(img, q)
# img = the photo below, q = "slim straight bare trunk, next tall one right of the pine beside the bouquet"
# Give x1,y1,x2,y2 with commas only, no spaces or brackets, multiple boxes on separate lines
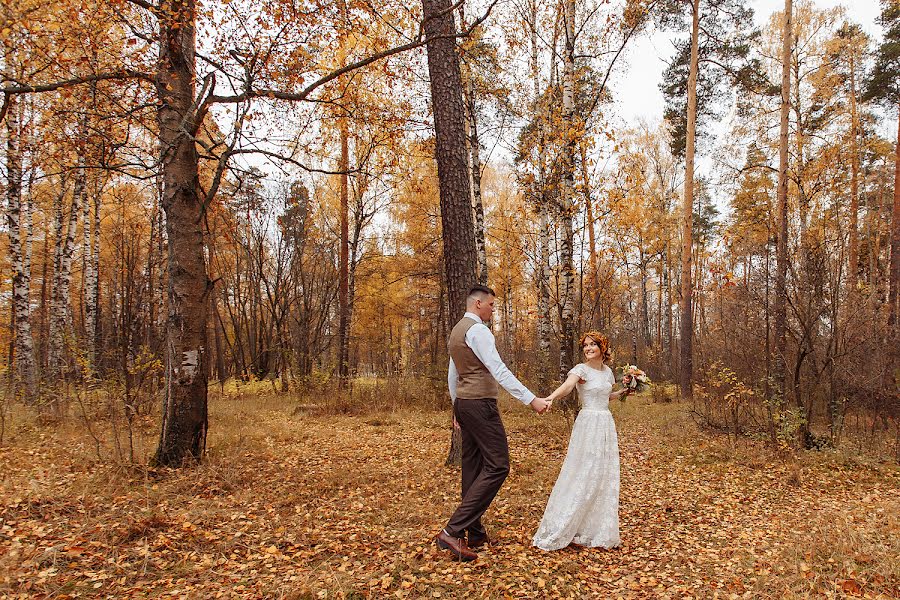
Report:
772,0,793,417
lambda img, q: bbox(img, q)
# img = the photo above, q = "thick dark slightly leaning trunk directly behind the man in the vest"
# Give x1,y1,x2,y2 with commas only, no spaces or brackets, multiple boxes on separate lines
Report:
422,0,477,464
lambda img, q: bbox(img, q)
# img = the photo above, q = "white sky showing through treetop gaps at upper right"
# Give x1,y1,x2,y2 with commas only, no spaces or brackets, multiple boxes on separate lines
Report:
613,0,881,124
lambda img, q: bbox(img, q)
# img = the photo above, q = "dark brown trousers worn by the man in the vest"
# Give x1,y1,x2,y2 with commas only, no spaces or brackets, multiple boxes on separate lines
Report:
445,398,509,538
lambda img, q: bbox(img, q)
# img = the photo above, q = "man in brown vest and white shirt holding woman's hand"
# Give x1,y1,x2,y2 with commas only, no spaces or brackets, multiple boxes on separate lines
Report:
435,285,550,560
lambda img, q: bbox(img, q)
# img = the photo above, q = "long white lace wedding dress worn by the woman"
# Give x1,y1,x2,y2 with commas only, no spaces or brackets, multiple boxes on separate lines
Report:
533,364,619,550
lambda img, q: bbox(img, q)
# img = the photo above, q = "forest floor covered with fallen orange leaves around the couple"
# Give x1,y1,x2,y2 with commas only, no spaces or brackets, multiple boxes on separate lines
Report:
0,382,900,598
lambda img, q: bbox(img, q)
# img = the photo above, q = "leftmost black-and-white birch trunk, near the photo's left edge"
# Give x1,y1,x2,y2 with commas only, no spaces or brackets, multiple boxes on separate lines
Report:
6,96,37,403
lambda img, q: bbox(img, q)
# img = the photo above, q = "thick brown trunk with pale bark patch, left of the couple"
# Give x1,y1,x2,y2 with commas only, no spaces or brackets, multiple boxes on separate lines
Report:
154,0,209,467
